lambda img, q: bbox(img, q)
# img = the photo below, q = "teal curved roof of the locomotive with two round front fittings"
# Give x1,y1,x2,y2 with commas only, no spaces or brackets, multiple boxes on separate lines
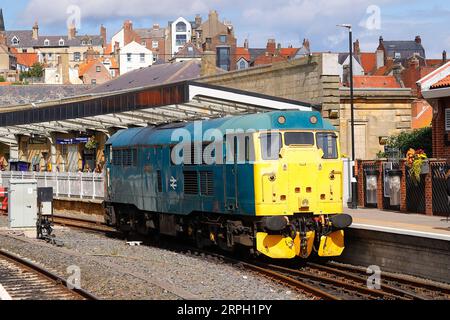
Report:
107,110,336,148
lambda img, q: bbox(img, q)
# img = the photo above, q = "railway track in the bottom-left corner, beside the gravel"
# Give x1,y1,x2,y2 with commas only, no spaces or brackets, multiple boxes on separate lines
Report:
0,250,97,300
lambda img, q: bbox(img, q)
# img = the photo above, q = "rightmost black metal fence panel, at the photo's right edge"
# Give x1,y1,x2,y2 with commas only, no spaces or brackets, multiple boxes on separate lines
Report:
430,162,450,216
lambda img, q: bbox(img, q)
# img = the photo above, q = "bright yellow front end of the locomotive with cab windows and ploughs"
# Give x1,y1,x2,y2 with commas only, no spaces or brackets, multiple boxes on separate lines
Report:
254,131,351,259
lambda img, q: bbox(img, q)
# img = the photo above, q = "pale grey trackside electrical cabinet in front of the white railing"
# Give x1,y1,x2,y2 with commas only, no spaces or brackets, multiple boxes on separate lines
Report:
8,179,37,228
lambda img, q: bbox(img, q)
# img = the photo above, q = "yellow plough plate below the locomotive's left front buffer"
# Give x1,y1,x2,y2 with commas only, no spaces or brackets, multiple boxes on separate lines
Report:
256,232,296,259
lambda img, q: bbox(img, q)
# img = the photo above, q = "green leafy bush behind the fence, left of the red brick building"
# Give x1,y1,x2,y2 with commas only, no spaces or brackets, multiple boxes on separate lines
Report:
387,127,433,158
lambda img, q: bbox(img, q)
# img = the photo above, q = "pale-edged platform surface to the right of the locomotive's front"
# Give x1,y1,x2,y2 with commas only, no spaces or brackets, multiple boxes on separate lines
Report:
344,208,450,241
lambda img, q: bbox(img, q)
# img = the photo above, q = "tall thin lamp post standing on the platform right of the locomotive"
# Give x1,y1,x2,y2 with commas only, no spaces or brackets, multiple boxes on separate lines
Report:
337,24,358,209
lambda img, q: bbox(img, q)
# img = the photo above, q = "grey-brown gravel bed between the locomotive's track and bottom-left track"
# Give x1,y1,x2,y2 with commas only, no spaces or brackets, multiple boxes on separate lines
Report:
0,217,307,300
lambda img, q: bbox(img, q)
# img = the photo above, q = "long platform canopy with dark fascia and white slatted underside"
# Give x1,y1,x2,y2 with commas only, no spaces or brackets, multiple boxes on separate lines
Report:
0,81,320,145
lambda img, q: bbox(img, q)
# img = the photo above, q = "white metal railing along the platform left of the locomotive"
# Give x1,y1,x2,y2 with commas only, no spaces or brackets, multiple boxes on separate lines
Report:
0,171,105,200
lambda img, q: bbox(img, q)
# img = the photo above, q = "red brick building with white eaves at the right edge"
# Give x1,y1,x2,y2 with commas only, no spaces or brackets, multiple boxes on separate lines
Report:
418,62,450,160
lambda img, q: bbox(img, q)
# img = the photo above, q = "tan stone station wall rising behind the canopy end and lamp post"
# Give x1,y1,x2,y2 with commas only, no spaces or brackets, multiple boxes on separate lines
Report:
200,53,413,159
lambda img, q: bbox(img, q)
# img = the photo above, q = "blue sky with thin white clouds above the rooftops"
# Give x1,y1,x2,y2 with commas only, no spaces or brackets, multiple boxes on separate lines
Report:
0,0,450,58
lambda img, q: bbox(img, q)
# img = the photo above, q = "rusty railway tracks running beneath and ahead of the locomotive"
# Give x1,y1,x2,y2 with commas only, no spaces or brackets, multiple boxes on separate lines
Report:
51,217,450,300
